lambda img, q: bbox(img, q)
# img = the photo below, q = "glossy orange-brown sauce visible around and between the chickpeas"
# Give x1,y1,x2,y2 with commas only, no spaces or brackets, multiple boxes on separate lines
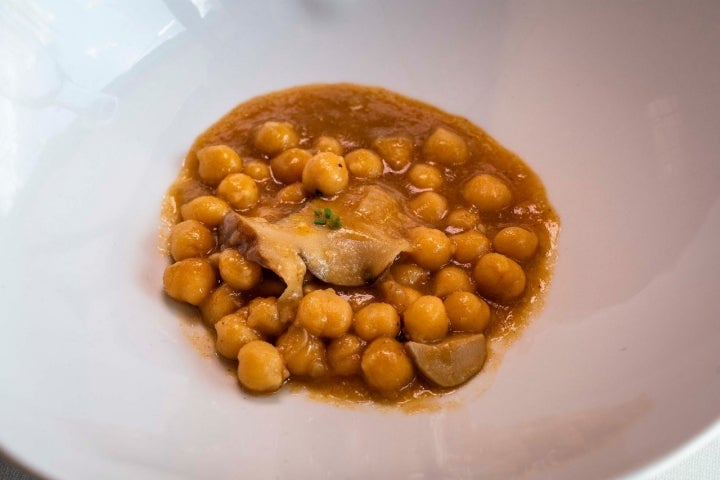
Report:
163,84,559,404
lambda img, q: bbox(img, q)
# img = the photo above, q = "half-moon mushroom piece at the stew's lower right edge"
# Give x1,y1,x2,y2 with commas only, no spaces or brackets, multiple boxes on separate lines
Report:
405,334,486,387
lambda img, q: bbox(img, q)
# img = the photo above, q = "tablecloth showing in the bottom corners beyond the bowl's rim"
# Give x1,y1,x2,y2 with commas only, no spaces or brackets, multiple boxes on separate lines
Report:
0,435,720,480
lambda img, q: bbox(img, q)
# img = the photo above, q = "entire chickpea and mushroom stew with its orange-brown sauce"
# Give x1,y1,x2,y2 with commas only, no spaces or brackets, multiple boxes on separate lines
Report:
163,84,559,403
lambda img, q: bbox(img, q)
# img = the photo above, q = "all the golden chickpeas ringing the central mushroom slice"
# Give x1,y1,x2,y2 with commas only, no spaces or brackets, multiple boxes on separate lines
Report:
163,121,538,396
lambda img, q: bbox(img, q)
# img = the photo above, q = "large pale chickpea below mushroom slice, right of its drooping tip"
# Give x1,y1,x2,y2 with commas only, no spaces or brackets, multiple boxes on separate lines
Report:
295,288,352,338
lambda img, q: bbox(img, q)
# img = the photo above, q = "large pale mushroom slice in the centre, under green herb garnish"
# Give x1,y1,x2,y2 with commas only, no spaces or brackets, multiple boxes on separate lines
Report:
220,186,414,321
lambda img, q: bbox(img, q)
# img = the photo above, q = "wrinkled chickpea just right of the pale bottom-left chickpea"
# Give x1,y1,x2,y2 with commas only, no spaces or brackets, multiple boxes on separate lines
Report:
275,326,328,378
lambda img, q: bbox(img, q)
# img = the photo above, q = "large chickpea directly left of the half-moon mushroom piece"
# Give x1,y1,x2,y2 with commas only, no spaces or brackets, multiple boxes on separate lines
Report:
360,337,415,393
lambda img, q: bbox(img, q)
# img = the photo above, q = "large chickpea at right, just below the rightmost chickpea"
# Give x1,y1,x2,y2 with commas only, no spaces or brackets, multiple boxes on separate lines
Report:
473,253,525,301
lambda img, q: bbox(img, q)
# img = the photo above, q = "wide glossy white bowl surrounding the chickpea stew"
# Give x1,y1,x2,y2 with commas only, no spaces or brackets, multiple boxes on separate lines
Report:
0,0,720,479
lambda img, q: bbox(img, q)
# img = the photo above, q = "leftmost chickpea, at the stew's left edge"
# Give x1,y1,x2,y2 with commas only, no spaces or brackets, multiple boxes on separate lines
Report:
163,258,216,305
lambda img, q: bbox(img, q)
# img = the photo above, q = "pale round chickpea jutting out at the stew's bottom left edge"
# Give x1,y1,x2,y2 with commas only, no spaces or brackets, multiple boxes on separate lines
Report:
238,340,290,392
